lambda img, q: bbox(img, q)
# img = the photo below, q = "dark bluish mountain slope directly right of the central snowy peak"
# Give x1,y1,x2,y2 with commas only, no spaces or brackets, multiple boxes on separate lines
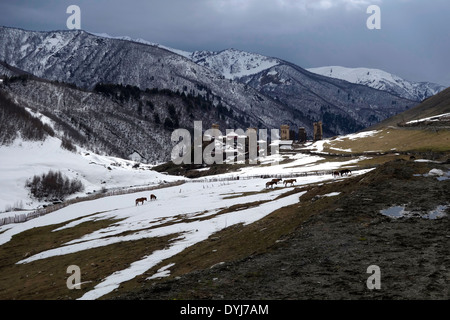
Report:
240,61,416,136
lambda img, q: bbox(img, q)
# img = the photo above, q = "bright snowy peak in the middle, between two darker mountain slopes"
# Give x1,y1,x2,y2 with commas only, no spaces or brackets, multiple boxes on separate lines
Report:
191,49,280,80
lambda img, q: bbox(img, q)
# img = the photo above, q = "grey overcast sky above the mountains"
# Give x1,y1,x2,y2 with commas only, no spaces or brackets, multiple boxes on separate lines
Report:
0,0,450,86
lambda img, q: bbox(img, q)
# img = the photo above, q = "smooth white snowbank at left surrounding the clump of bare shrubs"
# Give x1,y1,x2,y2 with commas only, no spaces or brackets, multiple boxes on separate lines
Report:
0,138,180,214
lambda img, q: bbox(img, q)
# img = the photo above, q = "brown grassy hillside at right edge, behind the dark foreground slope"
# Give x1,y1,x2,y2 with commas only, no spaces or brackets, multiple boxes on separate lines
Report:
315,88,450,160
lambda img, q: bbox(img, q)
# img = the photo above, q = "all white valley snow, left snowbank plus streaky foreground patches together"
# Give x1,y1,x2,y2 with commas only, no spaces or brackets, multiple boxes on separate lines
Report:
0,139,368,300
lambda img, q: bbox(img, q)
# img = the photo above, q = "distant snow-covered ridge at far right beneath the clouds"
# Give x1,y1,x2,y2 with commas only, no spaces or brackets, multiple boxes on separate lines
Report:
307,66,445,101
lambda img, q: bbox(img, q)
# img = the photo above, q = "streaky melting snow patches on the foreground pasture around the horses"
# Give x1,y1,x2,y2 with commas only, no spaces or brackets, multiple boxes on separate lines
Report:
0,177,318,299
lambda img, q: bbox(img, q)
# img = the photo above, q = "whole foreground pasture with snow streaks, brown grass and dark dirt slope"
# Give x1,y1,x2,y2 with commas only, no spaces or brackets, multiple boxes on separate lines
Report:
0,141,450,300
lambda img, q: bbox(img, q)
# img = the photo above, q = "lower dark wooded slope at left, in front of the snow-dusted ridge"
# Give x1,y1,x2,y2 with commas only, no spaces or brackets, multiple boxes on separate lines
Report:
0,71,260,163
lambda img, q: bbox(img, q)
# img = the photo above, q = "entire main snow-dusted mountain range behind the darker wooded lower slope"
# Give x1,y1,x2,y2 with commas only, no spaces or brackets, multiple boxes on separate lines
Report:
0,28,414,136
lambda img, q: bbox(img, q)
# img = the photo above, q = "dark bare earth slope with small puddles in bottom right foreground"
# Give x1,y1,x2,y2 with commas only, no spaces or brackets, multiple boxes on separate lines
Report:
110,161,450,300
